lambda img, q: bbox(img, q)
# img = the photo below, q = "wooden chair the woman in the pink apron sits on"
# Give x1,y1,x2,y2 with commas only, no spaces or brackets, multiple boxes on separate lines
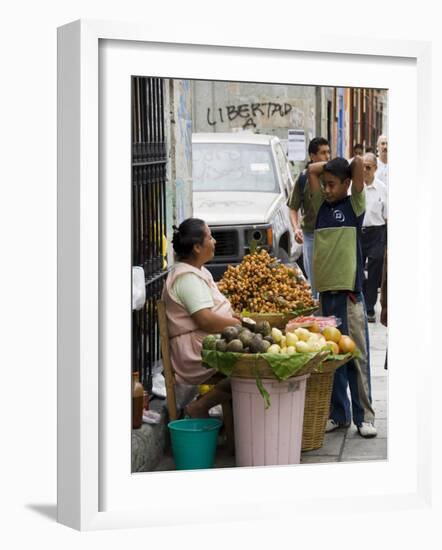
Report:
157,300,235,454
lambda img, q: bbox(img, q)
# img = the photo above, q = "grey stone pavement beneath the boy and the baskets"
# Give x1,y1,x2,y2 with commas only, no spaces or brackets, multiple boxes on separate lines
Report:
156,304,388,471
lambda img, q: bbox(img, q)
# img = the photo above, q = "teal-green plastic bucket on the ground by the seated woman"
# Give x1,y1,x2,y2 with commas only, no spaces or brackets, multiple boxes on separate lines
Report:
168,418,222,470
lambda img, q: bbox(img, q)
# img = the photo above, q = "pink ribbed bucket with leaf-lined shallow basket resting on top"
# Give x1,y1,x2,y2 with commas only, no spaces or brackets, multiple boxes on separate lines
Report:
203,351,327,466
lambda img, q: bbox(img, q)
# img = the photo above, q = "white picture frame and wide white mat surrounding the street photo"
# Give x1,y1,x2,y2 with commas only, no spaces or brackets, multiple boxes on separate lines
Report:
58,21,432,530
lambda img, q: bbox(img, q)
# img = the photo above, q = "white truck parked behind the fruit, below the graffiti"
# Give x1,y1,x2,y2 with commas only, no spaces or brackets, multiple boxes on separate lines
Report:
192,132,302,280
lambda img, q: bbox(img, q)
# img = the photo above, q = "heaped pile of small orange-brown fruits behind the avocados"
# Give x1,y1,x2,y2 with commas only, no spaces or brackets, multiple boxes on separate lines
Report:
218,250,318,328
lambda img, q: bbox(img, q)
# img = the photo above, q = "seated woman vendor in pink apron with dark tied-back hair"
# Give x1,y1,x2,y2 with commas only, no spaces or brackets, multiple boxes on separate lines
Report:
162,218,240,417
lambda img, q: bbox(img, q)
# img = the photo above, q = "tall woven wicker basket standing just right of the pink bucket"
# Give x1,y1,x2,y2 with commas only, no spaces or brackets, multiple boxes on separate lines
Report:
301,357,351,451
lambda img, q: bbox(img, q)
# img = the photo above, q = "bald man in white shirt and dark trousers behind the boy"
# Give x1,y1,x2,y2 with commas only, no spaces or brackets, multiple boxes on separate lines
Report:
361,153,388,323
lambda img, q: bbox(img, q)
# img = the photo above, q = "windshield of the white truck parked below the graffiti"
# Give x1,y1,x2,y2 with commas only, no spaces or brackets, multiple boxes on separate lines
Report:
192,143,280,193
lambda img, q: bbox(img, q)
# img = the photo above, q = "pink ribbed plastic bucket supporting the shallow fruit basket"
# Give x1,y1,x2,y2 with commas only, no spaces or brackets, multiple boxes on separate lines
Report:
231,374,310,466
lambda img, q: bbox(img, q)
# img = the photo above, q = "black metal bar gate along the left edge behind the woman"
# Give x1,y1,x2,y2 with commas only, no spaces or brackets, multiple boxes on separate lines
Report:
132,77,167,394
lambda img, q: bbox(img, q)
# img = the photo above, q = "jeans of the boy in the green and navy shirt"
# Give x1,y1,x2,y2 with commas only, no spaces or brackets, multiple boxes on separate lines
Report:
320,292,374,426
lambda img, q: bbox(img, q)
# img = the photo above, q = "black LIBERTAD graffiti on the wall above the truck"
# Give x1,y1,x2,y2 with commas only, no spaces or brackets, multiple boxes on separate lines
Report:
207,101,293,130
